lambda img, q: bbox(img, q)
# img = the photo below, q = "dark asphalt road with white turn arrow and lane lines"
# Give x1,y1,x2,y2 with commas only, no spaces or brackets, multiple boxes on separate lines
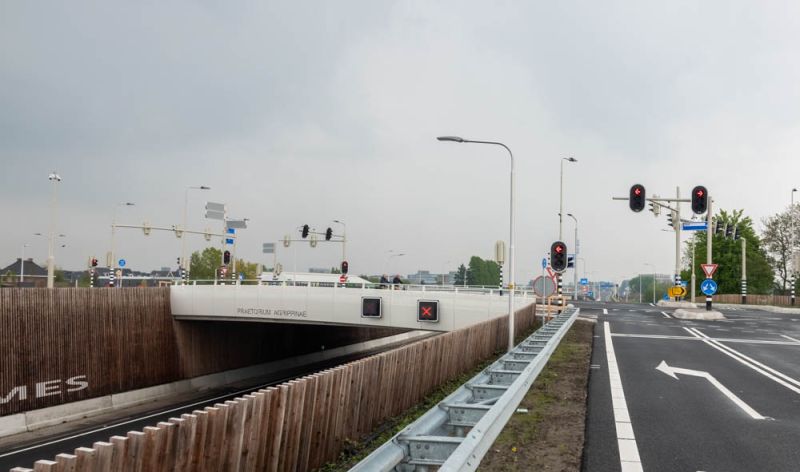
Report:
580,303,800,472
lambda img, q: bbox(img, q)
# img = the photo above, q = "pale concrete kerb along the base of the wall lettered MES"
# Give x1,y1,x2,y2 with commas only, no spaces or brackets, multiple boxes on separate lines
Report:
0,331,435,437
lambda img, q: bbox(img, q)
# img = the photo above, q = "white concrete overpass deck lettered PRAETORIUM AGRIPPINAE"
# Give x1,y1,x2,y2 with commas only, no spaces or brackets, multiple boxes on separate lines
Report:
170,283,536,331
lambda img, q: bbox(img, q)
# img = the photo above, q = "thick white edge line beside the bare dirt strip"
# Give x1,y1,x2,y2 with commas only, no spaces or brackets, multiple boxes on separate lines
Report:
603,321,643,472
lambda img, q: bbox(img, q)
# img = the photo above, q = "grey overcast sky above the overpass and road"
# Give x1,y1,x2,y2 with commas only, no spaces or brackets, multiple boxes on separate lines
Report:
0,0,800,281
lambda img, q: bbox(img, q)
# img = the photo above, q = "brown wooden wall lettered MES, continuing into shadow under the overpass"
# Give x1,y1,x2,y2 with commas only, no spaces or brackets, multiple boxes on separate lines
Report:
0,287,403,416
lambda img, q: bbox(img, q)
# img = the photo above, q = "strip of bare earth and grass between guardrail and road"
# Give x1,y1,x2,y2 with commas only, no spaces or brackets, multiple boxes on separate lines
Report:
479,319,594,472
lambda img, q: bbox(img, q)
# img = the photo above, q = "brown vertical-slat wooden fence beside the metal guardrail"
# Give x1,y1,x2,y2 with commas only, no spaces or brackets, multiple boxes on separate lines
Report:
15,306,534,472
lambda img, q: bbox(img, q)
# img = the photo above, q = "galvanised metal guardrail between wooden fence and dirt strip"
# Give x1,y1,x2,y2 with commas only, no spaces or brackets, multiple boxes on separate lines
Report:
350,308,580,472
